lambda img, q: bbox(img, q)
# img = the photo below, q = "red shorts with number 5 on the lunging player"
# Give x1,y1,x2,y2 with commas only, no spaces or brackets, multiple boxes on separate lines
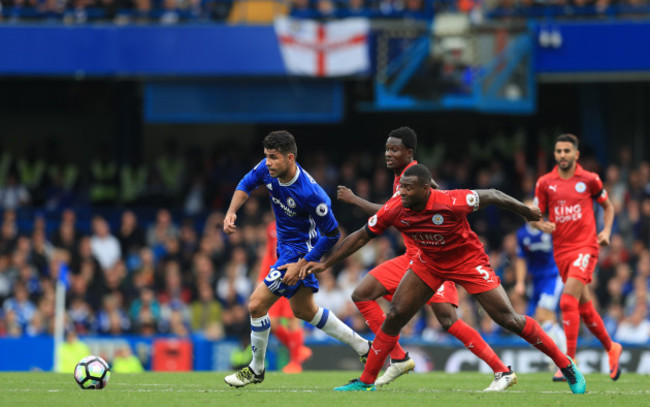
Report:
409,253,501,294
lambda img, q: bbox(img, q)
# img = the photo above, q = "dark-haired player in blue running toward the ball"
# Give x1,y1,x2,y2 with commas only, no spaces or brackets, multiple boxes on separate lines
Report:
223,130,370,387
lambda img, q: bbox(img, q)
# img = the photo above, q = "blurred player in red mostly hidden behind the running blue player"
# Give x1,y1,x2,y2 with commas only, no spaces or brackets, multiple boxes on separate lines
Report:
257,221,312,374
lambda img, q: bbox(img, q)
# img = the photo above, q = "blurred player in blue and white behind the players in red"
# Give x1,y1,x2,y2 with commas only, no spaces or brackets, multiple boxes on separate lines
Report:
514,199,567,381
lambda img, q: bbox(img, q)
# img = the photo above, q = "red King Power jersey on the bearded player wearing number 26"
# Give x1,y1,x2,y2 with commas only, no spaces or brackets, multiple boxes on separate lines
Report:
535,165,607,255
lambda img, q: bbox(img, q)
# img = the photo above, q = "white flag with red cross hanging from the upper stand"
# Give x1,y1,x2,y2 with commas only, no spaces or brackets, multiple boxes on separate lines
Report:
274,17,370,77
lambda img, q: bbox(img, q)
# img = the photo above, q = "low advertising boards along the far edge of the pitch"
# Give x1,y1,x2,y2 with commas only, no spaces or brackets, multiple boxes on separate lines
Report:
0,335,650,374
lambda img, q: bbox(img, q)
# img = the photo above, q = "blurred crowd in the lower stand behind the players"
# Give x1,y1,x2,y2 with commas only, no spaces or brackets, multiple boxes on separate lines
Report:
0,137,650,343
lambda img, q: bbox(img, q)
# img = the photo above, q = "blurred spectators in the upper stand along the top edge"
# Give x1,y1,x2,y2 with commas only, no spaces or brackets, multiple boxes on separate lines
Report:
0,0,650,24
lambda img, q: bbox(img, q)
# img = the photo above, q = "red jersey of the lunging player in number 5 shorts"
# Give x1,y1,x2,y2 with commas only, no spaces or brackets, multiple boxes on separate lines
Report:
366,189,489,270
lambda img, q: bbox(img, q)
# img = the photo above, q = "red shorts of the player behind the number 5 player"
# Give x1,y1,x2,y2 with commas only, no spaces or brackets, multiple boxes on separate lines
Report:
370,254,458,307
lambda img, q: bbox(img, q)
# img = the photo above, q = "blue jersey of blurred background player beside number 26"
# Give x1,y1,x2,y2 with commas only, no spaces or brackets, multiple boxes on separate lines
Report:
517,224,558,278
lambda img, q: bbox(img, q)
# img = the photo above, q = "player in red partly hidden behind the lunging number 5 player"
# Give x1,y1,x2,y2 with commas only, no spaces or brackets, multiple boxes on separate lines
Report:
337,127,517,391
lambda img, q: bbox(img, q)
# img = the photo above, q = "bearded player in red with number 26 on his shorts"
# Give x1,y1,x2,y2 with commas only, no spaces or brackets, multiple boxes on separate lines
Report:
535,134,623,380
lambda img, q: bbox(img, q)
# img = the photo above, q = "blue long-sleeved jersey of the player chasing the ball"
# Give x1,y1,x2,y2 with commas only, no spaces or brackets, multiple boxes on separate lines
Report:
237,159,338,255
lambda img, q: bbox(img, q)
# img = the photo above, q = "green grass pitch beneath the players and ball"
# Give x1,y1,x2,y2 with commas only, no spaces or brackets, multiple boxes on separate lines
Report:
0,371,650,407
